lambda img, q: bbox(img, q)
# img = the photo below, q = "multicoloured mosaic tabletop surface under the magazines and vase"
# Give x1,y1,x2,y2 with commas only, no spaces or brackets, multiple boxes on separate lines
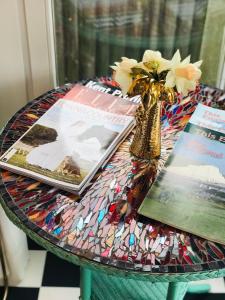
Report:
0,78,225,273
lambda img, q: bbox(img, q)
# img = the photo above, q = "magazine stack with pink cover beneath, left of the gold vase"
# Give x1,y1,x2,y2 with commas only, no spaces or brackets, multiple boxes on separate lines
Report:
0,84,137,194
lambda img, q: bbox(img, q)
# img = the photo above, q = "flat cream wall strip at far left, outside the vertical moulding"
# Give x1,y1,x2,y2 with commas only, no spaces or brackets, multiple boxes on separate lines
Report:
0,0,28,127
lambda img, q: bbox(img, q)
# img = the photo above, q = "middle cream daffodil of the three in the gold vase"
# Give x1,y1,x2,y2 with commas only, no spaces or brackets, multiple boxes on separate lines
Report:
142,50,171,74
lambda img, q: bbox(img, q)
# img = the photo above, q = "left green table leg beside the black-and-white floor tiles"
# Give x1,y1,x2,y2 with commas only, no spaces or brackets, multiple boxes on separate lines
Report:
80,267,91,300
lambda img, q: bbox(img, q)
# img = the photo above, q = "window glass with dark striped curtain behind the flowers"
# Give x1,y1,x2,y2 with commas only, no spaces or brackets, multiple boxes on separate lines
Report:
54,0,225,85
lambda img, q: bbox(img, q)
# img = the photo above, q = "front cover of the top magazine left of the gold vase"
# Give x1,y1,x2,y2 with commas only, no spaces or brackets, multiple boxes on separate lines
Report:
1,100,131,185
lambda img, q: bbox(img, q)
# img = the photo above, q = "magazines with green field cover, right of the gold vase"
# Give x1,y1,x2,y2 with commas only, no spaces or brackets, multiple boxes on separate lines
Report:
139,104,225,244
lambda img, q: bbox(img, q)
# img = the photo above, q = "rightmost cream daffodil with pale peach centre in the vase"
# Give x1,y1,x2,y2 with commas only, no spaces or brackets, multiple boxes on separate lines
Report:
165,50,202,96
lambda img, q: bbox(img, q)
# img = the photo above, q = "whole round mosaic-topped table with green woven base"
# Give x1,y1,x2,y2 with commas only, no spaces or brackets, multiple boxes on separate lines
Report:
0,78,225,300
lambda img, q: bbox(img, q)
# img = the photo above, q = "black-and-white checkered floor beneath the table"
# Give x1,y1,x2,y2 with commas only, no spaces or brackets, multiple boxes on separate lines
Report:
0,239,225,300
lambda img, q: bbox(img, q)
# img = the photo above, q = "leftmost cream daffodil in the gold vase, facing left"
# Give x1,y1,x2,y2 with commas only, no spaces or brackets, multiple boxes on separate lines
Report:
111,57,137,95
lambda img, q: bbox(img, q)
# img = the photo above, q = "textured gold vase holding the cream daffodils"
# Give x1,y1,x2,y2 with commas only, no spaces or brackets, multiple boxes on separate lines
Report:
129,78,174,160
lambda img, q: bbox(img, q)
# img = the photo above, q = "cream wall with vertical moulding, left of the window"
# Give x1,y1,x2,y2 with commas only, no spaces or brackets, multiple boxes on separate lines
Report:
0,0,55,128
